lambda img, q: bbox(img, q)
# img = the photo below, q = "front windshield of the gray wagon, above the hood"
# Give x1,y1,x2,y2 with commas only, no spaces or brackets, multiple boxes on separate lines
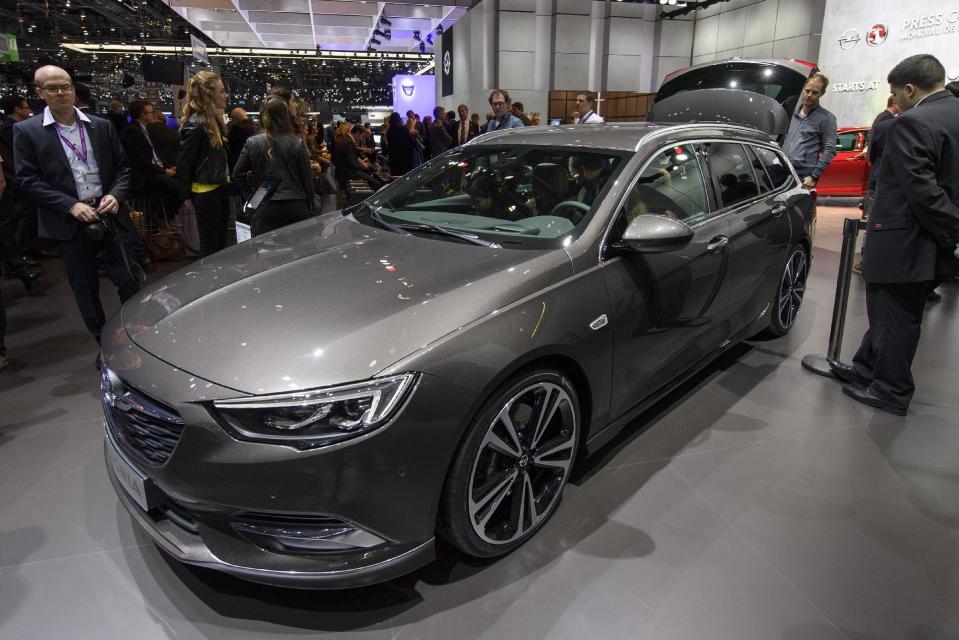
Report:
349,145,625,249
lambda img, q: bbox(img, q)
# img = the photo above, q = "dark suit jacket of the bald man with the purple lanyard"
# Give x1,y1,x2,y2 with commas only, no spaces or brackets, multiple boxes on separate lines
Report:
13,115,130,241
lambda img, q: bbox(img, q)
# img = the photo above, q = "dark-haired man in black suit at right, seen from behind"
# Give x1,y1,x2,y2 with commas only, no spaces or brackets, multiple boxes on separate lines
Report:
830,54,959,415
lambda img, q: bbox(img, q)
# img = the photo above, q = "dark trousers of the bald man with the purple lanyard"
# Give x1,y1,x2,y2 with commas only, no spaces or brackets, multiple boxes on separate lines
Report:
59,210,140,343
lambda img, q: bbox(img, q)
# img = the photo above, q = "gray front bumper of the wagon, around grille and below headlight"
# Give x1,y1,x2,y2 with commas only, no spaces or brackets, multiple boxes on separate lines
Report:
104,336,472,589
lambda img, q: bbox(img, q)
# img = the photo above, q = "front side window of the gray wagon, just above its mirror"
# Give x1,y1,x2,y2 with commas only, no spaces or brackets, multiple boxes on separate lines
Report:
625,144,709,224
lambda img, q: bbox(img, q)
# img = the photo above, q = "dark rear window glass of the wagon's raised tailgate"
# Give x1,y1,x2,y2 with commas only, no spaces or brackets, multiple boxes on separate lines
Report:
656,62,806,104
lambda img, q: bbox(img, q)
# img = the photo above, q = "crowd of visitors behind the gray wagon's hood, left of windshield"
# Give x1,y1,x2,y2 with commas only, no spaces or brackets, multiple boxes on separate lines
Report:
0,65,602,369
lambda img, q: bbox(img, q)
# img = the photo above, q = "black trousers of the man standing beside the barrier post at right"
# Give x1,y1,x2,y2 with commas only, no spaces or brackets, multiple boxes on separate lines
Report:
852,282,932,409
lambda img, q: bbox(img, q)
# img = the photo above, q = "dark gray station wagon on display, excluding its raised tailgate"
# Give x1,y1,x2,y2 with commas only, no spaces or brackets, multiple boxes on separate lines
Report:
101,116,815,588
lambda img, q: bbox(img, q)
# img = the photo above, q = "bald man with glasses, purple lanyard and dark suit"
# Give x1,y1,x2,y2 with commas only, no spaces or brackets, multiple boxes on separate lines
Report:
13,65,139,343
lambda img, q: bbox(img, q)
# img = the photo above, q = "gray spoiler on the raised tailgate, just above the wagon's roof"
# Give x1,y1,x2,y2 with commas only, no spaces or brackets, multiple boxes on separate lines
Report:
646,89,789,139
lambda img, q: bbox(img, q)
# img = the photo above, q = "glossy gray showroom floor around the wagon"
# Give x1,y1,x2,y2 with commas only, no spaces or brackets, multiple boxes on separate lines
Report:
0,207,959,640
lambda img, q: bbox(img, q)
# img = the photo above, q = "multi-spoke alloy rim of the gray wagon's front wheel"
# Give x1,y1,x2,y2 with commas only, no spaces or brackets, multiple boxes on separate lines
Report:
468,382,579,545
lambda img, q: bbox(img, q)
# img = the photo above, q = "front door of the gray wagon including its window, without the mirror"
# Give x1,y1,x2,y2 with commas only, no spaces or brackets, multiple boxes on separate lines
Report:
601,144,730,419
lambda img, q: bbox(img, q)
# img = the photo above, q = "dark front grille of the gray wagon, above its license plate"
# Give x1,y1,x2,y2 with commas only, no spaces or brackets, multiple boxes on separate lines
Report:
100,366,183,467
